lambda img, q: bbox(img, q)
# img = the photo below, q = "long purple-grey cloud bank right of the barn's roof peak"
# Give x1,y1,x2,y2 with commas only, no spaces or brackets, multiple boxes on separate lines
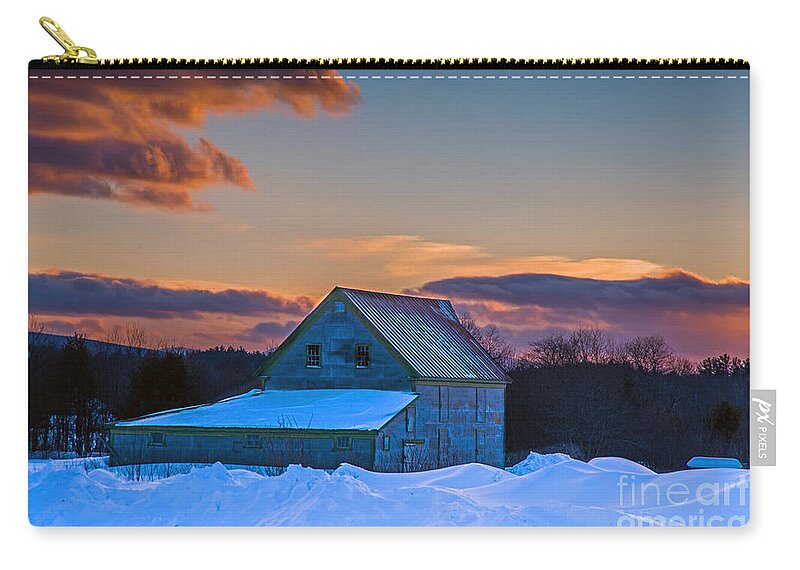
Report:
408,271,750,359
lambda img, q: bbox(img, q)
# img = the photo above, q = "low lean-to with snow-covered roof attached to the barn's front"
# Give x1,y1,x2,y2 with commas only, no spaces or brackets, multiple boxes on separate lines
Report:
110,390,418,471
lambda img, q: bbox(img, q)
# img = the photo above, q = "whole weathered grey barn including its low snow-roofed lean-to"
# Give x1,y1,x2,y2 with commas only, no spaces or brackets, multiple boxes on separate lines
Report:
109,287,509,472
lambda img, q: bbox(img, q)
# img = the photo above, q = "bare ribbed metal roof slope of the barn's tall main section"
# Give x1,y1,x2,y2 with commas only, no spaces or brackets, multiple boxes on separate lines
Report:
338,287,508,381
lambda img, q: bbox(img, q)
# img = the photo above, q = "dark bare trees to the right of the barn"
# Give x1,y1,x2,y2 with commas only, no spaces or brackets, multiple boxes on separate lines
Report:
456,319,750,471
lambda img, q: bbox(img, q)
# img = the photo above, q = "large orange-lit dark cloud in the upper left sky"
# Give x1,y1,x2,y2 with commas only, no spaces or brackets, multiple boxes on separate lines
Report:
29,71,360,210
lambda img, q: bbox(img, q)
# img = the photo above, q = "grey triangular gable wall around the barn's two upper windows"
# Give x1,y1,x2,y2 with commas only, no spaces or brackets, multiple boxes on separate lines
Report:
266,307,411,392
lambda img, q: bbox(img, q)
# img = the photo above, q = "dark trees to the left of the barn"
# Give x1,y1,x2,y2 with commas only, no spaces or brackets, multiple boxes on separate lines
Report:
28,332,265,456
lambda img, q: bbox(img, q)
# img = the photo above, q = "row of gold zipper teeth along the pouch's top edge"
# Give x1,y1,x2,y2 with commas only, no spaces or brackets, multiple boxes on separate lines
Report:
90,57,749,69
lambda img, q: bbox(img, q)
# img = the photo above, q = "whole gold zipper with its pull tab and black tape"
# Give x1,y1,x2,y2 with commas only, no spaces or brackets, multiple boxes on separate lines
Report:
28,16,750,70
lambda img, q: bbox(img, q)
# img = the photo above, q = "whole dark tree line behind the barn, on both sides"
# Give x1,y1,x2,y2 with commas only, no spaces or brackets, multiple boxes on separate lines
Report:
28,316,750,471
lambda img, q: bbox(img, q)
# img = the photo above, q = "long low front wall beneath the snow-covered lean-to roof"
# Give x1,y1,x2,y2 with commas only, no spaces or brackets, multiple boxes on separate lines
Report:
111,429,375,469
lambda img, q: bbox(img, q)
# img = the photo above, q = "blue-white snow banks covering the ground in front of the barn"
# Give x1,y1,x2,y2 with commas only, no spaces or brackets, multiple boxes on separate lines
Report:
28,453,750,526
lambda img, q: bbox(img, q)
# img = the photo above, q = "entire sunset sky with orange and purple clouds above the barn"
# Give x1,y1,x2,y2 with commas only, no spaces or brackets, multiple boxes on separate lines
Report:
29,70,749,359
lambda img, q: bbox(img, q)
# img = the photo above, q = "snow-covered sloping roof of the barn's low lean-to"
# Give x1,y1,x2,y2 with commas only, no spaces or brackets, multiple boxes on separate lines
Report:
115,389,417,430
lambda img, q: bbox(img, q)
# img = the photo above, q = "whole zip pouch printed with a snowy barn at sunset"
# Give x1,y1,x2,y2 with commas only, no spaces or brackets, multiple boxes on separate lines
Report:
28,18,750,527
